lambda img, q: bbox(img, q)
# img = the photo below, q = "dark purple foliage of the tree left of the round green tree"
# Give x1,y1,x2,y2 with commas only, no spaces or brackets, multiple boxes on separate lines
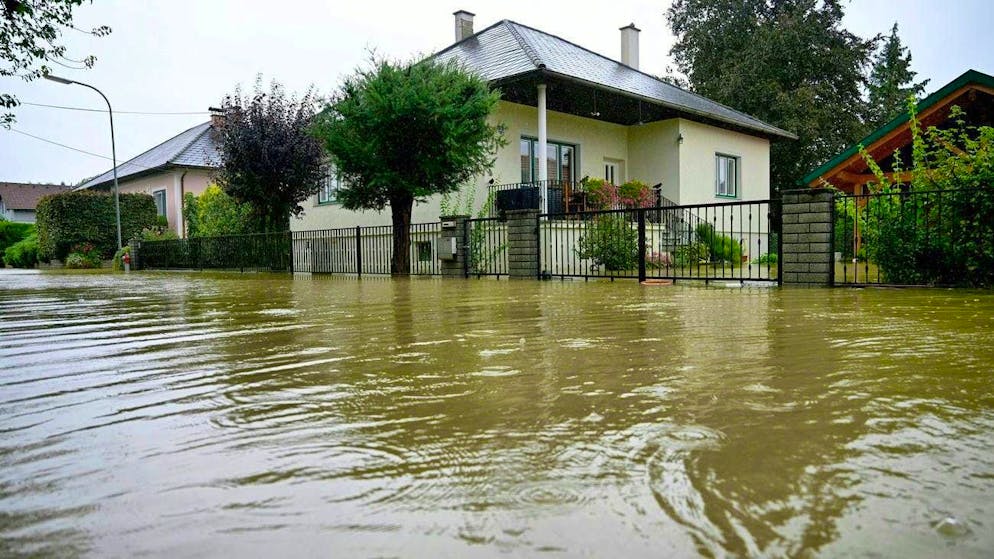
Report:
216,77,326,231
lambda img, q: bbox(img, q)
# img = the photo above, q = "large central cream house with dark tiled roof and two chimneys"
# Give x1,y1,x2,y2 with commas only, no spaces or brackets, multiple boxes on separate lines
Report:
291,11,796,230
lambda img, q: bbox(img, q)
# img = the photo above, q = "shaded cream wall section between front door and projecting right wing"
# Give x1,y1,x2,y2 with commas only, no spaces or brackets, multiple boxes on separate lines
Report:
628,118,680,202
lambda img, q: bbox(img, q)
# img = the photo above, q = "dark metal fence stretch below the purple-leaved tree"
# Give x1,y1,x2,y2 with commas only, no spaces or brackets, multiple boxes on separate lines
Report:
137,232,293,272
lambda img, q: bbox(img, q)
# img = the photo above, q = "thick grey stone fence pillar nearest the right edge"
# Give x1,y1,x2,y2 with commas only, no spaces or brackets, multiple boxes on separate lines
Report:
780,188,835,287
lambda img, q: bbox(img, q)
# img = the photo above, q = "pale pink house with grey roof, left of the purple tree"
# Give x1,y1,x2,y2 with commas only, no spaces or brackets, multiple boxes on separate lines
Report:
79,114,221,236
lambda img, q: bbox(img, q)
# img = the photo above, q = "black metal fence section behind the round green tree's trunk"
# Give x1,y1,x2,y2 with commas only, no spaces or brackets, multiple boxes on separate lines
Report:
293,222,442,276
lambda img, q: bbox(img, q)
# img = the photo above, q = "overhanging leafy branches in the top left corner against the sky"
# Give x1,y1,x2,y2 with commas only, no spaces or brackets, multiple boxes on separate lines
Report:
0,0,110,127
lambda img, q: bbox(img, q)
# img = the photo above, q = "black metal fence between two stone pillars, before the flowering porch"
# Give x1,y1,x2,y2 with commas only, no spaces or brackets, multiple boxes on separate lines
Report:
538,200,780,282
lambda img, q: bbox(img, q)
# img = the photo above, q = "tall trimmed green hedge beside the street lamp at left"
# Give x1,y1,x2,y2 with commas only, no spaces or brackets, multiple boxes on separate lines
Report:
36,190,156,261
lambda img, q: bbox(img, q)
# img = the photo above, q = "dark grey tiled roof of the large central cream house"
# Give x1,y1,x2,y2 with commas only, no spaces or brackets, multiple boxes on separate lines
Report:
435,20,797,139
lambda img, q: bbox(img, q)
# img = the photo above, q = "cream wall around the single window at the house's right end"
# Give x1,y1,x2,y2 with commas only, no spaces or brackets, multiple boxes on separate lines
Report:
673,119,770,205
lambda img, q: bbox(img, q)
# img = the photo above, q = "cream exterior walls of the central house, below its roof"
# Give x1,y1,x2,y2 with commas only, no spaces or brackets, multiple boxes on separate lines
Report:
290,101,770,231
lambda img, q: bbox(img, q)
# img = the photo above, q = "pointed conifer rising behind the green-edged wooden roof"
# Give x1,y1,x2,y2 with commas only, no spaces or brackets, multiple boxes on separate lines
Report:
867,23,928,128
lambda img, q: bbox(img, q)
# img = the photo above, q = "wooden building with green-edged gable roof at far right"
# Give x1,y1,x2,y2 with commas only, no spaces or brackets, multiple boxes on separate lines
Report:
802,70,994,194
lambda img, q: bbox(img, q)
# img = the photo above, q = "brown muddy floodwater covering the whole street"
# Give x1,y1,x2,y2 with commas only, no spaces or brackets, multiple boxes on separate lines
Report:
0,271,994,558
